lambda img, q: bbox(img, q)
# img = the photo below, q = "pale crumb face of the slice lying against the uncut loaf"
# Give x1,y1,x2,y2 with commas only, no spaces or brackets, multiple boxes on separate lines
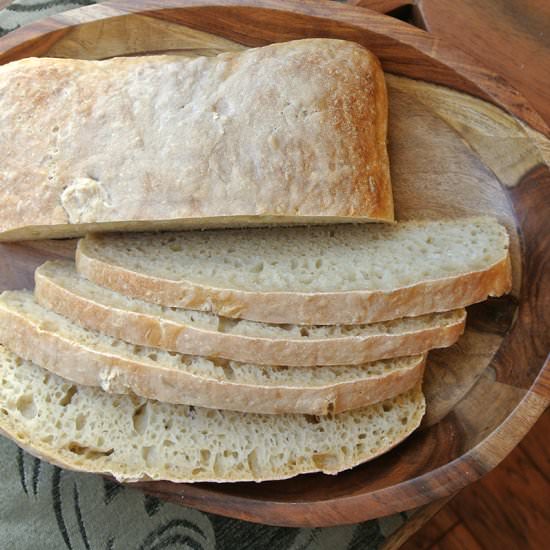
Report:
82,218,508,293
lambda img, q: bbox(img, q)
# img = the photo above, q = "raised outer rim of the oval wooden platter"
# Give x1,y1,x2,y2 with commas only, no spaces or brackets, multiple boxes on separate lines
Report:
0,0,550,526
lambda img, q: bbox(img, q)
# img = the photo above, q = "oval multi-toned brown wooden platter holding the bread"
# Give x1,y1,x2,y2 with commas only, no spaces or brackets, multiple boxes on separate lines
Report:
0,0,550,526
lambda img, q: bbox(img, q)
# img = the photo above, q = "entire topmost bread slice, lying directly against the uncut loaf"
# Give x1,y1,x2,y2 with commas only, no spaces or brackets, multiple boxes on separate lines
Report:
77,218,511,325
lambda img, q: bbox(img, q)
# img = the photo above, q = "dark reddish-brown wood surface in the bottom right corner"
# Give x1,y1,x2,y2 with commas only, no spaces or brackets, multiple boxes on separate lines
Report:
402,410,550,550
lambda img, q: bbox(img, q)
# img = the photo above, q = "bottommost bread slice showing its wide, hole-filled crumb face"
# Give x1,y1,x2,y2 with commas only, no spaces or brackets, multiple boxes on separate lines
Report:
0,346,425,482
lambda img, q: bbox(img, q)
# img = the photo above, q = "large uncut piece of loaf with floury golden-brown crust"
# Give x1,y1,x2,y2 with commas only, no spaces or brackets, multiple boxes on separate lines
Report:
0,39,393,240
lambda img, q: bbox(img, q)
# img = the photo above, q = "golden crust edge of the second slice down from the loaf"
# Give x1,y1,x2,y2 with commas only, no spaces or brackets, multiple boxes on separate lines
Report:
34,262,466,367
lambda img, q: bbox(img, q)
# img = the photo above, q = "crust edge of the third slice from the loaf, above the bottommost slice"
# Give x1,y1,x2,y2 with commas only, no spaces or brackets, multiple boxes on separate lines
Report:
0,302,426,415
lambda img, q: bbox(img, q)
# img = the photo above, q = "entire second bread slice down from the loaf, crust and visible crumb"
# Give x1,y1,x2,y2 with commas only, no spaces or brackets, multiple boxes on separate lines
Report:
34,262,466,367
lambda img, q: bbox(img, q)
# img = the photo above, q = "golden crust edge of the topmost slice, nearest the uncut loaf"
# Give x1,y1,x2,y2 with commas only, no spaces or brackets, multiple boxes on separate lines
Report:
76,237,512,325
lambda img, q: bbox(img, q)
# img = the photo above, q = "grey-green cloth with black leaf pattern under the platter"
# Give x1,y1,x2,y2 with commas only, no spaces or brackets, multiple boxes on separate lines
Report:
0,0,414,550
